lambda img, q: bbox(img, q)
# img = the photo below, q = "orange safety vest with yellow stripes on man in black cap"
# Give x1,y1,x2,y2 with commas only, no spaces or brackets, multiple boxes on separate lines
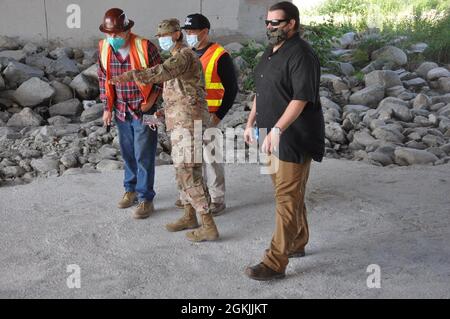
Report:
200,43,227,113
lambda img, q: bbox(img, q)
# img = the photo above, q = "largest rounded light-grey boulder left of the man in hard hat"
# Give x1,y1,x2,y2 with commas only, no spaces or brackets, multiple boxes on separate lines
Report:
14,78,56,106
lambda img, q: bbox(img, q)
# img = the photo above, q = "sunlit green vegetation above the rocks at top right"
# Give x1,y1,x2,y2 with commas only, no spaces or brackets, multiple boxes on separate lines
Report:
305,0,450,67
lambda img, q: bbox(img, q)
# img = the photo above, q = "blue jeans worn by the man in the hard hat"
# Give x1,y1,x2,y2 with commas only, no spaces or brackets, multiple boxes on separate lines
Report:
115,112,158,202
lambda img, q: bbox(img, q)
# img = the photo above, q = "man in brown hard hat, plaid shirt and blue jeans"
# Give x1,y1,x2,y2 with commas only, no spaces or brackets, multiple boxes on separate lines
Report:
98,8,162,219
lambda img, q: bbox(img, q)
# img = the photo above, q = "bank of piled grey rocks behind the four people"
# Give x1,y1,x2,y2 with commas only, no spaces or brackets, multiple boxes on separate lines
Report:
0,33,450,182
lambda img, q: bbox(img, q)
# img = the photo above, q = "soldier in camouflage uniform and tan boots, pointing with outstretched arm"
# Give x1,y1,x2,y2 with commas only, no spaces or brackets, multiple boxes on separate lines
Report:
111,19,219,242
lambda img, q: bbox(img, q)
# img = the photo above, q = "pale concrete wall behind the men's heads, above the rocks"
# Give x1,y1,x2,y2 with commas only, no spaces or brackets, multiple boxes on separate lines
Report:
0,0,288,47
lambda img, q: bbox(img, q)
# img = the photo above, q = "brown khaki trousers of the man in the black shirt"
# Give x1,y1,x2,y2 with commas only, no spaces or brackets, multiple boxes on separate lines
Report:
263,159,311,272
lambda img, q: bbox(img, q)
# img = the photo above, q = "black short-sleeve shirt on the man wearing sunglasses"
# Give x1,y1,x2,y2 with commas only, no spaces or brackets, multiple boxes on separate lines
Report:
254,34,325,163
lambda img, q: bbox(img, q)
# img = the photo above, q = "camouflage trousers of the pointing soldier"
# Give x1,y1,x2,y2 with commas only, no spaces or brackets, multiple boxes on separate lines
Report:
170,129,211,214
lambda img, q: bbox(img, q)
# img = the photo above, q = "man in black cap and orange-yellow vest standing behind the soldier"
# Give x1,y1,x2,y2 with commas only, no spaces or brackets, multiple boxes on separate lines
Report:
176,13,238,216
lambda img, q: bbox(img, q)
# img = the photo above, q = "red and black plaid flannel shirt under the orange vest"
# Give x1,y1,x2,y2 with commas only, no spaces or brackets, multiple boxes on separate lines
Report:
98,41,162,121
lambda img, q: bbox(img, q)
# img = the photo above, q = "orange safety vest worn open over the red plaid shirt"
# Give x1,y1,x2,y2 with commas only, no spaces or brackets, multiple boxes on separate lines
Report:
98,34,153,111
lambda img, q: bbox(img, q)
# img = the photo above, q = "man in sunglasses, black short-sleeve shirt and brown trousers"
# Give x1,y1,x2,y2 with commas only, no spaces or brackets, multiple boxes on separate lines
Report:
244,1,325,280
